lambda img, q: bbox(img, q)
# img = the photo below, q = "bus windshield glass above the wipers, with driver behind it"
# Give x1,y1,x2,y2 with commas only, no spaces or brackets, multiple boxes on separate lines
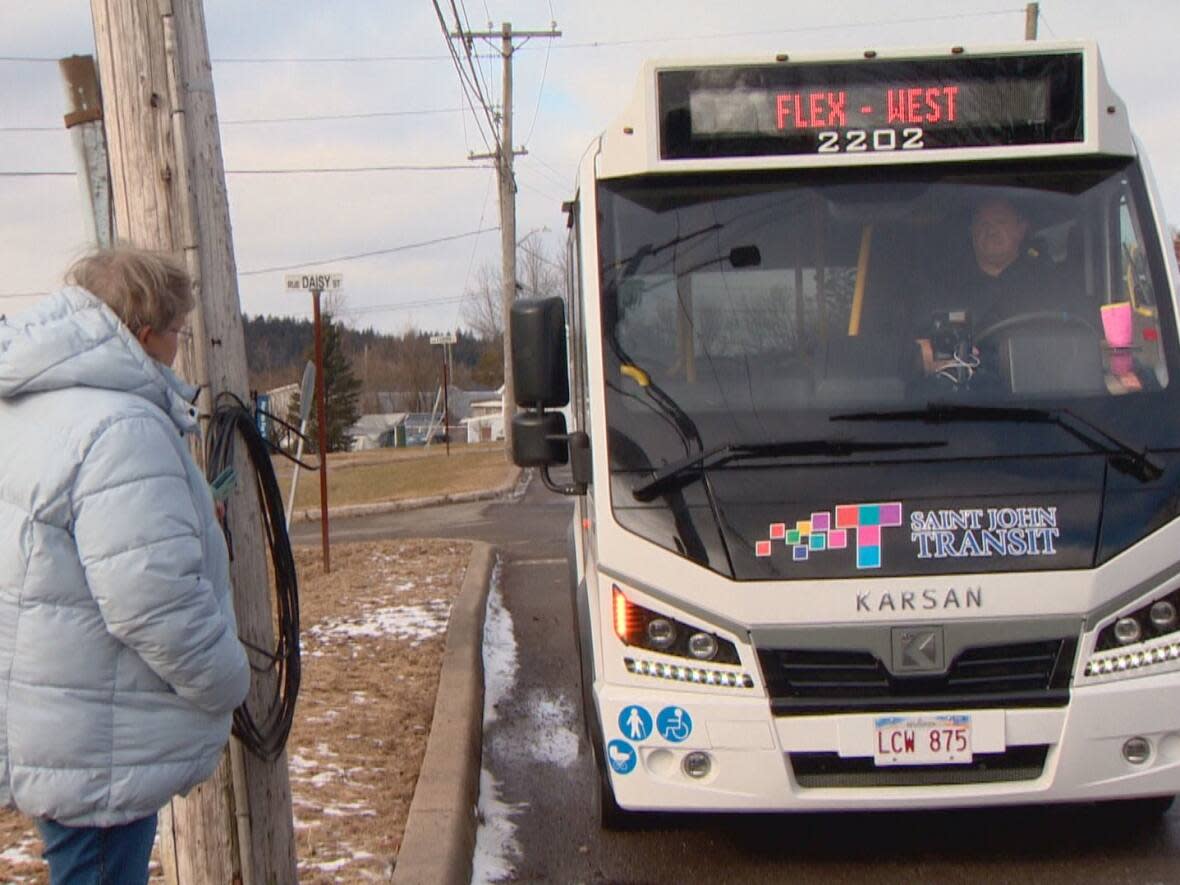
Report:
598,158,1176,468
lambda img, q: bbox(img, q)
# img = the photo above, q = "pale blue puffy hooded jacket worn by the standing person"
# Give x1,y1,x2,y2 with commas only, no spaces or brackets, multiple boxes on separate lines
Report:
0,288,250,826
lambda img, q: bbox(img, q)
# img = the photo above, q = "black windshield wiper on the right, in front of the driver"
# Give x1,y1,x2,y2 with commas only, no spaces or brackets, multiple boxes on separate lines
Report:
831,402,1163,483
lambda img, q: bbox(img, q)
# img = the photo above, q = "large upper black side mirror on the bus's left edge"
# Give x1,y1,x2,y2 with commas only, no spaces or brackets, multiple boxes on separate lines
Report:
511,295,570,408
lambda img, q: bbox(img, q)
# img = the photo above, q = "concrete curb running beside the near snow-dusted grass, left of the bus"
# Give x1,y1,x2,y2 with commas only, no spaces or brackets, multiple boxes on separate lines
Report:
393,542,496,885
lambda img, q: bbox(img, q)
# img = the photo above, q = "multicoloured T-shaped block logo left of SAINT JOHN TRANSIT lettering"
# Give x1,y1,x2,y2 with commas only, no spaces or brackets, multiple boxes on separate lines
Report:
754,502,902,569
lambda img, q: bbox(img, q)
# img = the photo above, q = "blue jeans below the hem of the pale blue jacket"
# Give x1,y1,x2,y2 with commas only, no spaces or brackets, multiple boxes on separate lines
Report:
37,814,156,885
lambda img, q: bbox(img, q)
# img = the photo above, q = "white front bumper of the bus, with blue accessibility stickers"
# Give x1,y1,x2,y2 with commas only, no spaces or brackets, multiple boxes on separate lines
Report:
596,673,1180,812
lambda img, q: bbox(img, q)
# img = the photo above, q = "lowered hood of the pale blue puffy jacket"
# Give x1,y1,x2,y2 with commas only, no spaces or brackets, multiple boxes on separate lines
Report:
0,287,197,432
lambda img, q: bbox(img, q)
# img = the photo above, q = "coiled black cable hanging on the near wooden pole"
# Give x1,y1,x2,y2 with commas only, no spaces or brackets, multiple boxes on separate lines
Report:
205,393,300,761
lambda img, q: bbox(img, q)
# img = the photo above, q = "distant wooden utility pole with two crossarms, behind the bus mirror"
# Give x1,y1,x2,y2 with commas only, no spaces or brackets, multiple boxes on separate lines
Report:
452,21,562,460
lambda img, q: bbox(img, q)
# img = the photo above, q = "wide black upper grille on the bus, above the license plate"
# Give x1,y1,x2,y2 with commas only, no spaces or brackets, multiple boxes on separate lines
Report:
759,638,1077,716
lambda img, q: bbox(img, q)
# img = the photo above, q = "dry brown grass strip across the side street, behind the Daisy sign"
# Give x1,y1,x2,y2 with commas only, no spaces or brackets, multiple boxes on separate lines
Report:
275,445,516,511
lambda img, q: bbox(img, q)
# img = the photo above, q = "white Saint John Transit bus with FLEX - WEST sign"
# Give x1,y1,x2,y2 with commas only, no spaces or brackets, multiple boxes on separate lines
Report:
512,42,1180,826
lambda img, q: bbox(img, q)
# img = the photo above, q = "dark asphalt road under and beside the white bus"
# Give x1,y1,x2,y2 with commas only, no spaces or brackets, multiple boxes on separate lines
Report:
294,483,1180,885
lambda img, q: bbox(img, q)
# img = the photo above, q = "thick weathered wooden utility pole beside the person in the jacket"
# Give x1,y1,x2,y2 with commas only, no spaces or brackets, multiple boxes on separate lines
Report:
91,0,297,885
